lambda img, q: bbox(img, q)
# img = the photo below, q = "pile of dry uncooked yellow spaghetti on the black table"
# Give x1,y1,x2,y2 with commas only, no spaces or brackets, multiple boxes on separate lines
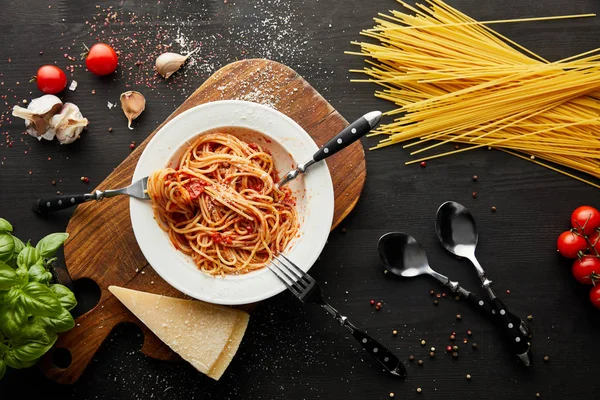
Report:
349,0,600,188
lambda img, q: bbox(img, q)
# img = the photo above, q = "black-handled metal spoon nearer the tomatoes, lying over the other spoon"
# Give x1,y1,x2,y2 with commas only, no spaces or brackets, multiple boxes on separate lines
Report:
435,201,532,366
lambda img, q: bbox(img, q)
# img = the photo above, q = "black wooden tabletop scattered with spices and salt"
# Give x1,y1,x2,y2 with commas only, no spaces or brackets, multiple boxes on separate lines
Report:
0,0,600,399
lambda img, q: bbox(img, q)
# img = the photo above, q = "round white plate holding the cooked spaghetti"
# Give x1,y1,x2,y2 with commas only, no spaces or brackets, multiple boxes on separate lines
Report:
130,100,334,305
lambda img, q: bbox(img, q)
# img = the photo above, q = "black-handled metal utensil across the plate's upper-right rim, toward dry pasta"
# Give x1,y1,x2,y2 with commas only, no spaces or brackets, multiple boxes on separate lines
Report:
277,111,382,187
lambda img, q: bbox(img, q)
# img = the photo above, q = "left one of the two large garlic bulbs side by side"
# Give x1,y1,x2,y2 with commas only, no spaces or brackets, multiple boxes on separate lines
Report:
12,94,63,140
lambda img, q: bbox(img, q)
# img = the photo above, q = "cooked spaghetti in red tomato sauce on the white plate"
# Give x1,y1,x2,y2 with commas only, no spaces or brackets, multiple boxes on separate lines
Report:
148,133,298,276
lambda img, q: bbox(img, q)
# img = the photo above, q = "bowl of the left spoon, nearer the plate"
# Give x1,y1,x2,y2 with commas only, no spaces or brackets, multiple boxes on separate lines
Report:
377,232,433,278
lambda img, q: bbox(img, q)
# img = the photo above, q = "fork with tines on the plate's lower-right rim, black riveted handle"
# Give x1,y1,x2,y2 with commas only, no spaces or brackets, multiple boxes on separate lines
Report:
267,254,406,377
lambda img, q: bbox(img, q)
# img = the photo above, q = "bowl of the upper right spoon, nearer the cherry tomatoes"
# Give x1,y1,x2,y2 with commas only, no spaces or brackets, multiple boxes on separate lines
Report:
435,201,478,258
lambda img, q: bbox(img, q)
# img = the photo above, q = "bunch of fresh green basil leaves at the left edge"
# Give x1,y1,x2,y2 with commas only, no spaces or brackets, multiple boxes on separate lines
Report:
0,218,77,379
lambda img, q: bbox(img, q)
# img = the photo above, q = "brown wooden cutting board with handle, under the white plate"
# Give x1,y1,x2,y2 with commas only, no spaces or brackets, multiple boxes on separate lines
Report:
40,59,368,384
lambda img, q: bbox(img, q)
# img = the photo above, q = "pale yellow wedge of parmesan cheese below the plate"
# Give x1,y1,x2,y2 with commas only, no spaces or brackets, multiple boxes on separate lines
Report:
108,286,250,380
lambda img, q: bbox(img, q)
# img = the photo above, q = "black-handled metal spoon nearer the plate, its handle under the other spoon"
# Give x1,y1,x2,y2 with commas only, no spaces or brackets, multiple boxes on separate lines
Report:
377,232,494,317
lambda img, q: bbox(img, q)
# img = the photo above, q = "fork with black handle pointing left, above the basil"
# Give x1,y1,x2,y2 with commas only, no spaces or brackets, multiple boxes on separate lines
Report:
33,176,150,214
